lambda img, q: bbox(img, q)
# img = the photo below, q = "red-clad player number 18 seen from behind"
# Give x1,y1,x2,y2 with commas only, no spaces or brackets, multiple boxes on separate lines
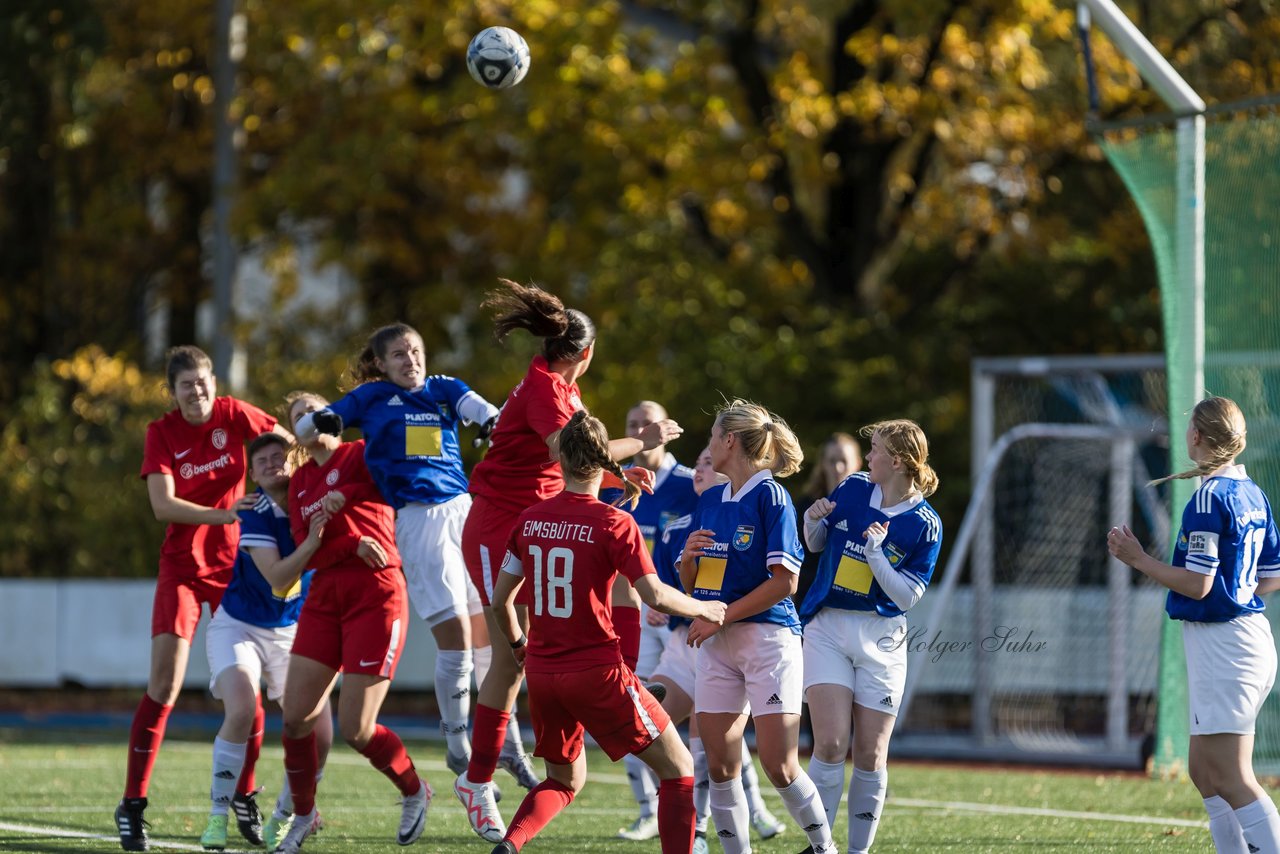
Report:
483,411,724,854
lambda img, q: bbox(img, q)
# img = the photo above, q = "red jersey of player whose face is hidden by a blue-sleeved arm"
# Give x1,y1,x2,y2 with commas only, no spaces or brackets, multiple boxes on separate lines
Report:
289,439,401,570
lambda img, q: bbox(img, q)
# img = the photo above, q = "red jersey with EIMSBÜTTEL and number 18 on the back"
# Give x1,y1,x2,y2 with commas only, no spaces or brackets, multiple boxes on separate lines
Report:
502,492,654,673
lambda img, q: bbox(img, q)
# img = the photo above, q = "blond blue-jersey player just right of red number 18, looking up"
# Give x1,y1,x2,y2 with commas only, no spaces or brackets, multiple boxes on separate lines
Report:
680,401,836,854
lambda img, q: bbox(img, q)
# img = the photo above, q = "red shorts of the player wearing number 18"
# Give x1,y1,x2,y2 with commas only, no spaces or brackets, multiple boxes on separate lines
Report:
525,663,671,766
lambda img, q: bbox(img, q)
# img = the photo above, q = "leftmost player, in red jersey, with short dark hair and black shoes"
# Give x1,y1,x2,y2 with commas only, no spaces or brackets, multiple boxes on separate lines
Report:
115,346,292,851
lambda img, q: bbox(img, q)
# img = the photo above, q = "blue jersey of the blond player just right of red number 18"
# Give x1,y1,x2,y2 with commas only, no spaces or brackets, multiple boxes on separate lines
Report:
689,471,804,634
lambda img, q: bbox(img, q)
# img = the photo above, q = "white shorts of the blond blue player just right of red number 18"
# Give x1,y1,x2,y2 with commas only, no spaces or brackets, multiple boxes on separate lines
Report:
694,622,804,717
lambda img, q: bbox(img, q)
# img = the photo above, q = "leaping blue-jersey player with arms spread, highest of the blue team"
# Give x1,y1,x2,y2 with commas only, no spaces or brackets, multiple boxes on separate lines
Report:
294,323,538,789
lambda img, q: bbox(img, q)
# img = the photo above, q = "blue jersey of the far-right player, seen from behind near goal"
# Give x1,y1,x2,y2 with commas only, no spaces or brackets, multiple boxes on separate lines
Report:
1165,466,1280,622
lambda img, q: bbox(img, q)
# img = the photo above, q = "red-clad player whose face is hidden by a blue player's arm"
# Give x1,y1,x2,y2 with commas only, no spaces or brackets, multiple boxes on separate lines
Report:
276,392,431,854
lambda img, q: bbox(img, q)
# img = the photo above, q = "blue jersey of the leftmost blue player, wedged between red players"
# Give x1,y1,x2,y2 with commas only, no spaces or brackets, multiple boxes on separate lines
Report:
219,489,315,629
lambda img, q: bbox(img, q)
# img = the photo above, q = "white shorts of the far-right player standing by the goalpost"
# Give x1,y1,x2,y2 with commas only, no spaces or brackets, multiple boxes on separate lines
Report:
1183,613,1276,735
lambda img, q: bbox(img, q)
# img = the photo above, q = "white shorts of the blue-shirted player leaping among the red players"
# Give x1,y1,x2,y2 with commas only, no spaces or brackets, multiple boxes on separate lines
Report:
396,495,481,626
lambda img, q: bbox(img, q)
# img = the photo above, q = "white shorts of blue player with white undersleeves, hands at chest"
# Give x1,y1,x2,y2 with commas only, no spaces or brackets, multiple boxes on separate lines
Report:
804,608,906,716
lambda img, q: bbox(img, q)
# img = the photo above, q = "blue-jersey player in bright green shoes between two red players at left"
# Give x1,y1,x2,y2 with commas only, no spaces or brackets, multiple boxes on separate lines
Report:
200,433,333,850
